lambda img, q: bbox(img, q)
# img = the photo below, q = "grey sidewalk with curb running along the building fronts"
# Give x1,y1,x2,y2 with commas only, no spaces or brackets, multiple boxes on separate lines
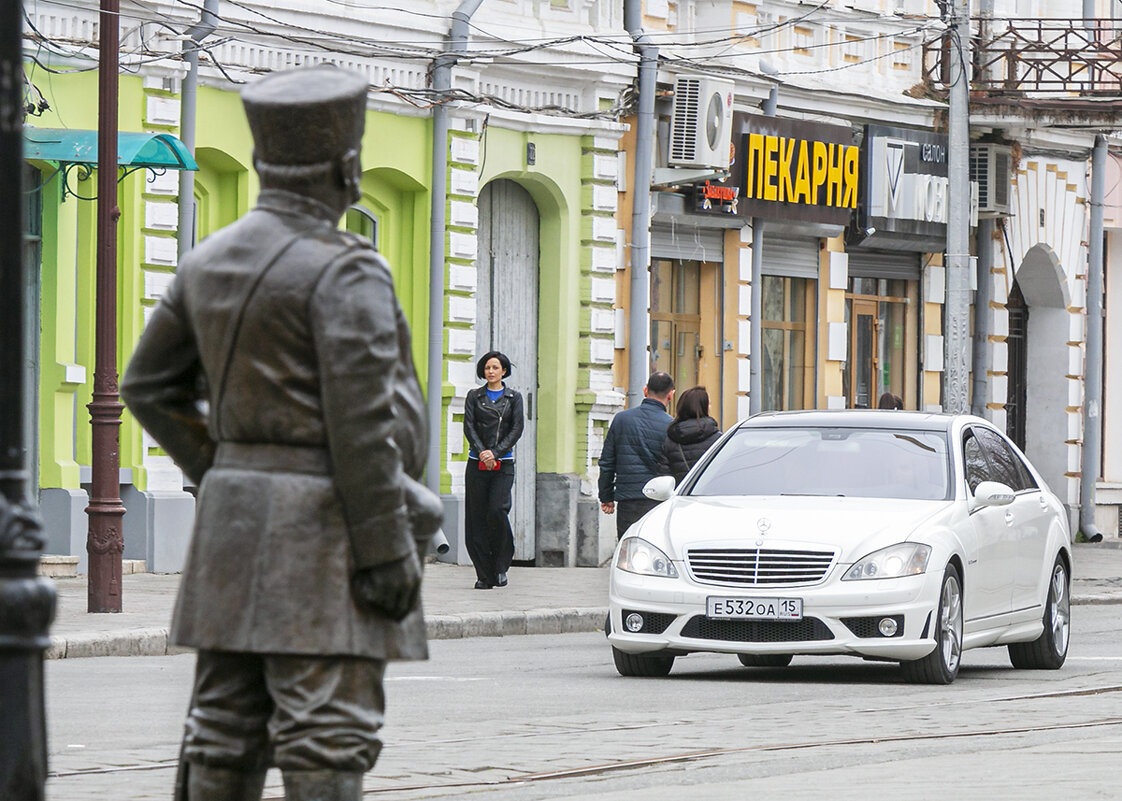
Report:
47,541,1122,659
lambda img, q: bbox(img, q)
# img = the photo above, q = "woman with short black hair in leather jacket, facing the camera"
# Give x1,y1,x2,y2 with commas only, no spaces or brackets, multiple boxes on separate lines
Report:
463,350,523,590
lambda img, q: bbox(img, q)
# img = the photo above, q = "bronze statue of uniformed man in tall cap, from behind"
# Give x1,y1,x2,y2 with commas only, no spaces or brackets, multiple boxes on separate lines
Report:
121,66,440,801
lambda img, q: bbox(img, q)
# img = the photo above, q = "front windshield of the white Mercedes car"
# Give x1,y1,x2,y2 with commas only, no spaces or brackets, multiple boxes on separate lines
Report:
686,426,949,500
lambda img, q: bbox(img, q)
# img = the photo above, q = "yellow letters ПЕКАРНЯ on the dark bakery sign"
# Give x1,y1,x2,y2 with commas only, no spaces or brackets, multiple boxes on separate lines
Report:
744,134,859,209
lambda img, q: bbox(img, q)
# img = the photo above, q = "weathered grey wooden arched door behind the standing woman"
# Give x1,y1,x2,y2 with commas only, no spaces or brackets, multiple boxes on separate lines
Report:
476,179,540,560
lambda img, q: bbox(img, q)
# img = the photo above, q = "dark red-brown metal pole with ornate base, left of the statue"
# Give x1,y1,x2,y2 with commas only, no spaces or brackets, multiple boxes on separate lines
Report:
85,0,125,611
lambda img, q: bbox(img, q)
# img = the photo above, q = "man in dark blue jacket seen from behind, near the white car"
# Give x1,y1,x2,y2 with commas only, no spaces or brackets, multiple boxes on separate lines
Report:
599,370,674,538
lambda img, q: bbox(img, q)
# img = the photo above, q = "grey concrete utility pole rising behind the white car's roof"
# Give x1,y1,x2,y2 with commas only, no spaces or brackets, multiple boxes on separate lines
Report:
942,0,973,414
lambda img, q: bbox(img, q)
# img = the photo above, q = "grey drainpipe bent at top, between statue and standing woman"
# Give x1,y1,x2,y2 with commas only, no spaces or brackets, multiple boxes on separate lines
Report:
425,0,484,495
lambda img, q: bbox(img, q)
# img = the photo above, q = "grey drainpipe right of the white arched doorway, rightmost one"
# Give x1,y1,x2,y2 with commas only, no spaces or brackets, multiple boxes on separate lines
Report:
1079,134,1106,542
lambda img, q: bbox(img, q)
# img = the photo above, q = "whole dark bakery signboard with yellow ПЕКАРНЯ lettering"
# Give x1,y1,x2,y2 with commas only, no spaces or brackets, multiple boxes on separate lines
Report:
733,113,861,224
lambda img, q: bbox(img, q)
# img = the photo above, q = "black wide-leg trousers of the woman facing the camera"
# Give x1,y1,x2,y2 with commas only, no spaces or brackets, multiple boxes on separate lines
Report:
463,459,514,586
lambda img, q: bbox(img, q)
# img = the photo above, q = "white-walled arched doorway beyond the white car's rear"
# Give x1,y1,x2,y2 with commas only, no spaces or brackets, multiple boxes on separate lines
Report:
1006,245,1072,500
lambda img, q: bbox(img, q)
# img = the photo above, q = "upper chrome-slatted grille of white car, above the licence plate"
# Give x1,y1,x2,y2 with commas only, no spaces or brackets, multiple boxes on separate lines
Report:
686,547,834,587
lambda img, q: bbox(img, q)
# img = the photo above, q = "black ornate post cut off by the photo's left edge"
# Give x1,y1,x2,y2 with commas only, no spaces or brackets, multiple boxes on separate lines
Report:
0,2,55,801
